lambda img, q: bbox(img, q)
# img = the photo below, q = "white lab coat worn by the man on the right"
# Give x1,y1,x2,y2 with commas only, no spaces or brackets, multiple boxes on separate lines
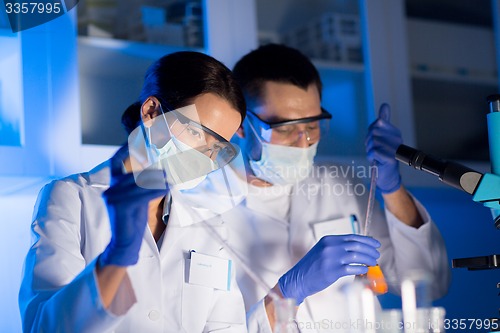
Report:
223,167,450,332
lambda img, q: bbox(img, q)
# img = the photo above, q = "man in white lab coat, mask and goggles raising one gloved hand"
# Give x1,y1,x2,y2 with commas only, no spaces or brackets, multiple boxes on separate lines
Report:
227,44,449,332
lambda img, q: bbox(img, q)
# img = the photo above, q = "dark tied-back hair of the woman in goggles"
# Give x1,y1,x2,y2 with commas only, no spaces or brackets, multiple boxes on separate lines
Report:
122,51,246,134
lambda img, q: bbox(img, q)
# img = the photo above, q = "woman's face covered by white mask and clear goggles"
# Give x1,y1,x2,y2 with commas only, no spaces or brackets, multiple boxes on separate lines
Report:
128,104,241,188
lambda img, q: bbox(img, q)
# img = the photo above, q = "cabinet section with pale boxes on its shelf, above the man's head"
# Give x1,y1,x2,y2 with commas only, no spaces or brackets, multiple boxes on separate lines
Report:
256,0,364,72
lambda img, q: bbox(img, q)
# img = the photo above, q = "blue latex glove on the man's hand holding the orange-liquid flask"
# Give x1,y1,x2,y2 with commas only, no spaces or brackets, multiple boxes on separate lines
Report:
278,234,380,304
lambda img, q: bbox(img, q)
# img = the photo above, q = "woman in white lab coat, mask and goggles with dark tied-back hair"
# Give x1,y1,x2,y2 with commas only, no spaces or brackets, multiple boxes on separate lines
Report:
19,52,250,333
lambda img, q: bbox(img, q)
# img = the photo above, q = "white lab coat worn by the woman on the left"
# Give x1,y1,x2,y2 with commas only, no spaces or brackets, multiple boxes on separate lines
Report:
19,162,246,333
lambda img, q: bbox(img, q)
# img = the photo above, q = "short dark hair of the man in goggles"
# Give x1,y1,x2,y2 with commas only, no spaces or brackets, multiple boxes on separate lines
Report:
233,44,323,103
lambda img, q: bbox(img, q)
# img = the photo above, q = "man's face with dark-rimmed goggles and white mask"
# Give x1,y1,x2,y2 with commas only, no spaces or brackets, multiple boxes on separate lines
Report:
243,91,332,185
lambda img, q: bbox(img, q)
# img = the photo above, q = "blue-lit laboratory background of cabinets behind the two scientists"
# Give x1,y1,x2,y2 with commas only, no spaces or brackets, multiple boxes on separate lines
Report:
0,0,500,332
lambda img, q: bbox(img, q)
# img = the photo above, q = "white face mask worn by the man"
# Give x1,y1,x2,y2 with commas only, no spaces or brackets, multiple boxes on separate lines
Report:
248,121,318,185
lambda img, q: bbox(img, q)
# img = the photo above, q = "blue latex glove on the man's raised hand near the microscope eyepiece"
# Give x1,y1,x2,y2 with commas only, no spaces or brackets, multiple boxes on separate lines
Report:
365,103,403,194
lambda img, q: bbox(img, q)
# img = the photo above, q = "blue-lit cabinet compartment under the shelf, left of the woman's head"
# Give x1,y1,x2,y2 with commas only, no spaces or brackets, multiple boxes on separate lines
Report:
78,37,205,145
